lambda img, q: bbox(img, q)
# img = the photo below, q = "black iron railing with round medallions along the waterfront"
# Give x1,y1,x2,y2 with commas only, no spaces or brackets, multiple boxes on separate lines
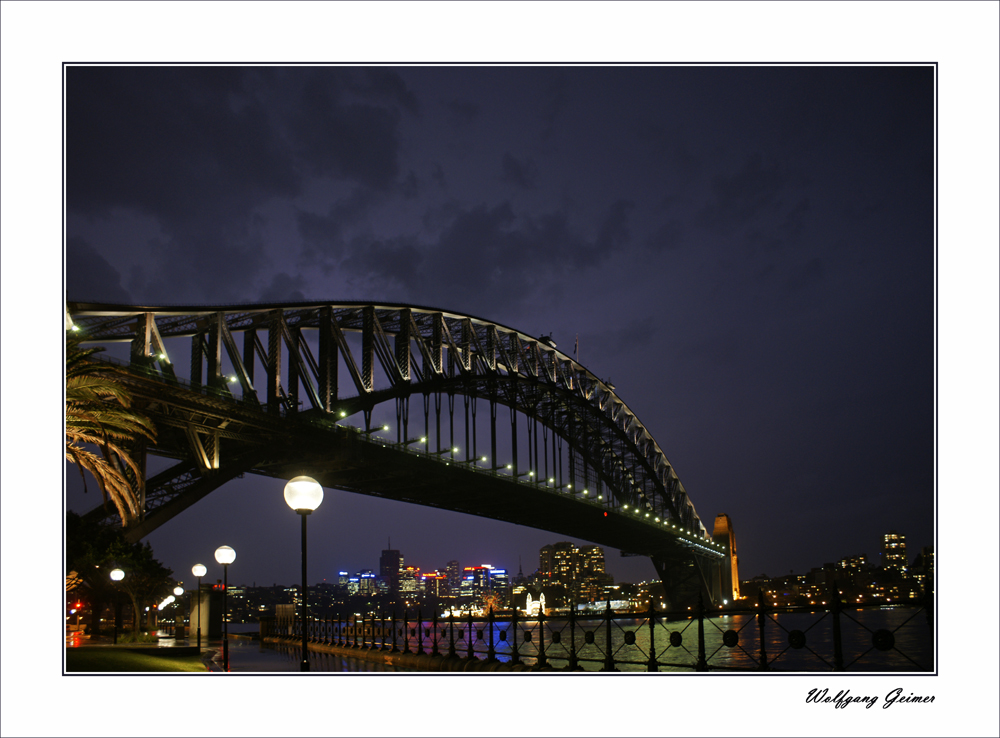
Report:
261,594,934,672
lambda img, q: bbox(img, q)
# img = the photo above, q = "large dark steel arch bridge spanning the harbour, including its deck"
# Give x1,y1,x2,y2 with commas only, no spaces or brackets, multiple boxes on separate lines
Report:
67,302,727,605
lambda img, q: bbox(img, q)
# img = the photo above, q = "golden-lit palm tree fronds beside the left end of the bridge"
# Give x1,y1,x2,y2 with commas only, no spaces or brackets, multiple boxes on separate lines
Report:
66,332,156,526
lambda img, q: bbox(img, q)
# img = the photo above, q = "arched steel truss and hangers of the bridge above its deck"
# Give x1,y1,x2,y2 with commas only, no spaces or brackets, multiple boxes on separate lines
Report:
67,302,720,572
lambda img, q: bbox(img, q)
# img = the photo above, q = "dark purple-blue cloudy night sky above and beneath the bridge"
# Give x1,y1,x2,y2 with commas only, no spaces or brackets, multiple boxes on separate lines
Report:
66,66,934,584
